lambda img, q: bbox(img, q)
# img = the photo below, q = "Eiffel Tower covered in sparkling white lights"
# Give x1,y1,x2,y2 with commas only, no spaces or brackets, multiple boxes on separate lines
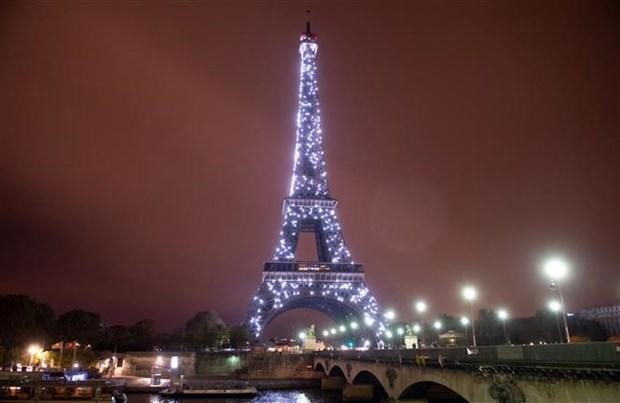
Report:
244,21,386,338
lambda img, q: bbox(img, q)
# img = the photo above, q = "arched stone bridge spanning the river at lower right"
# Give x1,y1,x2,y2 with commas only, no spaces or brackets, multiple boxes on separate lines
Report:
314,343,620,403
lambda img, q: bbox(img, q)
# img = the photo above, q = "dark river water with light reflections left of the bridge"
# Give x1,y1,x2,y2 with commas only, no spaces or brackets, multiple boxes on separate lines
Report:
127,389,341,403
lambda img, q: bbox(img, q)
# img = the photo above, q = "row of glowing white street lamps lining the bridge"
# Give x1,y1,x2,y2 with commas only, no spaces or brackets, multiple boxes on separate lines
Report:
299,257,570,347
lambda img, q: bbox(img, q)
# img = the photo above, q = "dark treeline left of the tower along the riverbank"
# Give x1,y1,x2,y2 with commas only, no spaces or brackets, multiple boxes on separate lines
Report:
0,295,249,365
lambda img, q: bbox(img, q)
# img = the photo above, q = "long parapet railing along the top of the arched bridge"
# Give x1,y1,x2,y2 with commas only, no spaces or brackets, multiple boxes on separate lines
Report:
317,342,620,368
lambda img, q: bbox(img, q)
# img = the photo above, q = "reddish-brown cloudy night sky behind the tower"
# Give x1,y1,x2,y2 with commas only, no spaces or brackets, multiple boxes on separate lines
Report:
0,1,620,338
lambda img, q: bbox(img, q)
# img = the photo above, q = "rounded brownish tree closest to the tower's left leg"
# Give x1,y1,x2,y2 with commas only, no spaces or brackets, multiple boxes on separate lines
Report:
183,311,228,351
